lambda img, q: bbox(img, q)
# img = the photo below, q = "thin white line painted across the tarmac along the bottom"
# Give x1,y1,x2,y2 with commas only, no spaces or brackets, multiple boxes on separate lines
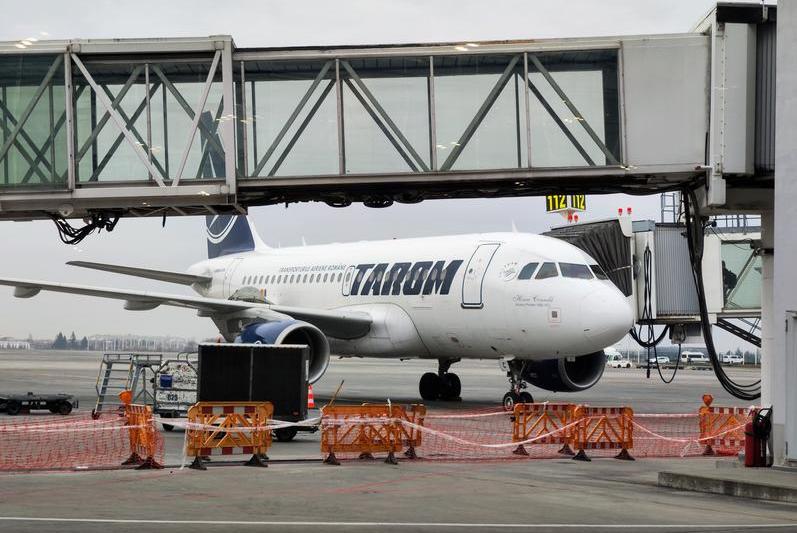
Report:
0,516,797,529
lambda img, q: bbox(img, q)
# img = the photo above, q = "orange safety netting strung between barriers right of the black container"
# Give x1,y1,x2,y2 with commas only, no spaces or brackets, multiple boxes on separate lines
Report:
321,408,743,460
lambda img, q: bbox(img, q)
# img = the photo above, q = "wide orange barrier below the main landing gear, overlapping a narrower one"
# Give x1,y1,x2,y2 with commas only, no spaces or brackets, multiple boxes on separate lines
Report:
321,405,404,465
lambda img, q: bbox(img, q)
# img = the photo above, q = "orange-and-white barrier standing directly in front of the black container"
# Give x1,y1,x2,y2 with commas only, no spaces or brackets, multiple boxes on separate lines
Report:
186,402,274,470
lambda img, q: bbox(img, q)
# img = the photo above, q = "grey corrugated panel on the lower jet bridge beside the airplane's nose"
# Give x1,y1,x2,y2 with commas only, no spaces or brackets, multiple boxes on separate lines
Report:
653,224,700,317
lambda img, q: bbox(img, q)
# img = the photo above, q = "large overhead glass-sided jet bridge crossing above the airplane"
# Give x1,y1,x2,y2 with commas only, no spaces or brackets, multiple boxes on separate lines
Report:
0,5,767,220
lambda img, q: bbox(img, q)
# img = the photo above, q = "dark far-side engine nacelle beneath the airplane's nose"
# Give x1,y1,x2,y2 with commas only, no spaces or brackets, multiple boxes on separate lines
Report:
523,351,606,392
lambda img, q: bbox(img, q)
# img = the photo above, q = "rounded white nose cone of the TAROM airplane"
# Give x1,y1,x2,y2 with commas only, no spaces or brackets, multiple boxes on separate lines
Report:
581,287,633,349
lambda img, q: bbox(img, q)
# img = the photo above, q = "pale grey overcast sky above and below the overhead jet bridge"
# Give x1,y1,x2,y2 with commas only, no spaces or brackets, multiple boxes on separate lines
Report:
0,0,748,352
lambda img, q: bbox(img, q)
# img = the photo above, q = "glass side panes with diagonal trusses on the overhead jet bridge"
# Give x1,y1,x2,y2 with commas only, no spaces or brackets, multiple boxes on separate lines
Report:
0,45,623,188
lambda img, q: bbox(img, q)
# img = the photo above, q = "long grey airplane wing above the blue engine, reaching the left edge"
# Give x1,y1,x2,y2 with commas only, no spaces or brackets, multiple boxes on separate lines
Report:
0,278,372,339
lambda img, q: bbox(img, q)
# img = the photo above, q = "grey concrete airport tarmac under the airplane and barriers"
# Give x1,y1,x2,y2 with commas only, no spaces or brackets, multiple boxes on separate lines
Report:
0,352,797,532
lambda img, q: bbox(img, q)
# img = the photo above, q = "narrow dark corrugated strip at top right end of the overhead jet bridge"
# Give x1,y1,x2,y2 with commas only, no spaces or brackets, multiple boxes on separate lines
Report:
754,22,776,174
